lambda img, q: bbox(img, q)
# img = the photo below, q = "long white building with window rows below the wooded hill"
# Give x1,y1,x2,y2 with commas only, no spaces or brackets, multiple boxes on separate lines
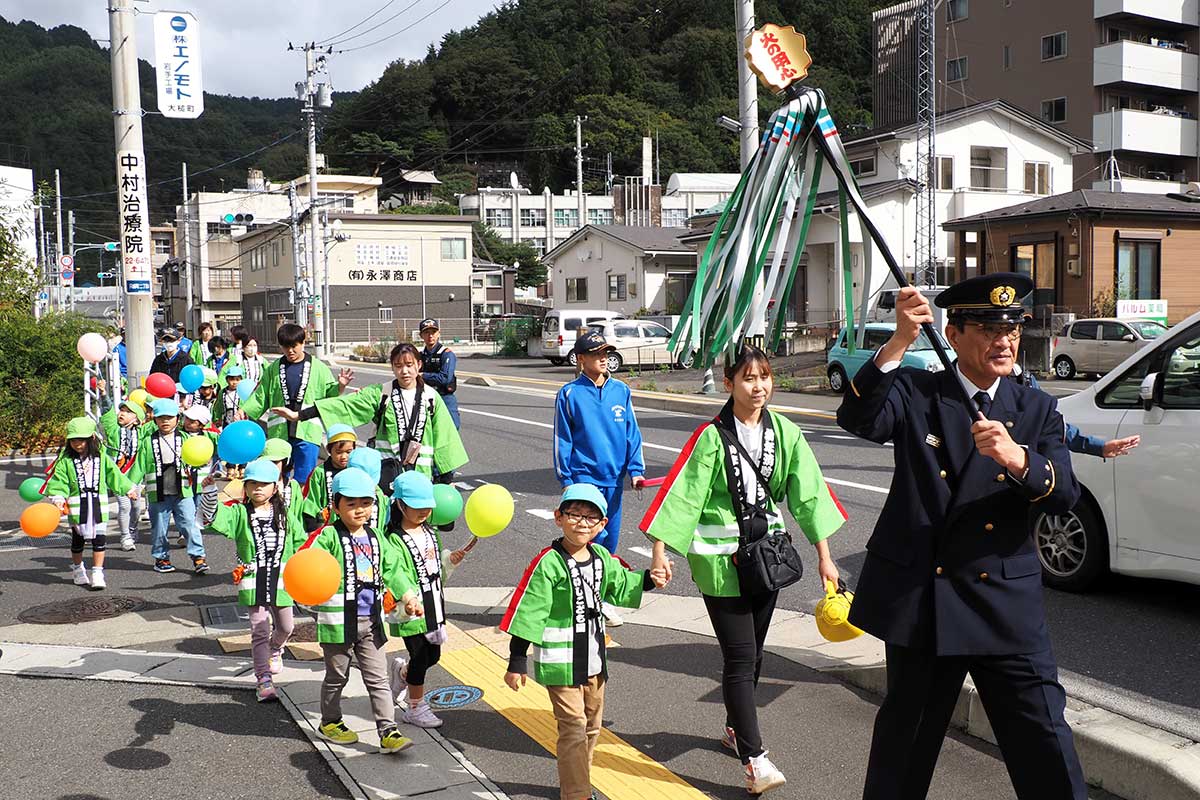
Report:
458,173,740,253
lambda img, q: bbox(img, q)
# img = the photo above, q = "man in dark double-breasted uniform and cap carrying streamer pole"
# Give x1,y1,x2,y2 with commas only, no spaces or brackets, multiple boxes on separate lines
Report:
838,272,1087,800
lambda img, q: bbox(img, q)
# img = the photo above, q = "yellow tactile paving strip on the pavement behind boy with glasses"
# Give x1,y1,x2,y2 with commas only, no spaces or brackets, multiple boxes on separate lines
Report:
440,647,708,800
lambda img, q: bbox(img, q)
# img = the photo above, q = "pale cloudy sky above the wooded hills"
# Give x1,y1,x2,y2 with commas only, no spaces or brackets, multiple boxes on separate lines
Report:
7,0,500,97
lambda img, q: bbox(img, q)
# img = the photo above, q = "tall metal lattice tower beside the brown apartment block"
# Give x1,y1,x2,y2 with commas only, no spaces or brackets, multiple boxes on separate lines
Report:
913,0,937,285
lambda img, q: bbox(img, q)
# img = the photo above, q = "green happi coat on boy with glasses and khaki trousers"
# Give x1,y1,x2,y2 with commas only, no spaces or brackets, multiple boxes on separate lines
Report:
500,540,646,686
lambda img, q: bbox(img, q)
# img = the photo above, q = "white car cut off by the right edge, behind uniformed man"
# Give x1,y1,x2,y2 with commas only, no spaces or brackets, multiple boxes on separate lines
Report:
1030,313,1200,591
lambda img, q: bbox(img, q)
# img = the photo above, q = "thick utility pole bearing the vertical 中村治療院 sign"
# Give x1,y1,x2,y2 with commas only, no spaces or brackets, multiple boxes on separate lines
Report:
104,0,154,385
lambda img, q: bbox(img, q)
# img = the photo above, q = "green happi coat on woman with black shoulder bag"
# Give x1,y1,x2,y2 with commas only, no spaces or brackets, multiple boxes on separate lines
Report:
638,409,846,597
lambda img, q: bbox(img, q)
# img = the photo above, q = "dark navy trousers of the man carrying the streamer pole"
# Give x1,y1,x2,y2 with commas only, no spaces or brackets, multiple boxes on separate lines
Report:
863,644,1087,800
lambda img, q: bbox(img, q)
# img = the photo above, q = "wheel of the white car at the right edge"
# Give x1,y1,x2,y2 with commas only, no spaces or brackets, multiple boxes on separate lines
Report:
1032,498,1109,591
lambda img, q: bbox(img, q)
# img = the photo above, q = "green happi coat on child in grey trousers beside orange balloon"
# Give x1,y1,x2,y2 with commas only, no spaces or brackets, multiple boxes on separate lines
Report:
301,521,416,644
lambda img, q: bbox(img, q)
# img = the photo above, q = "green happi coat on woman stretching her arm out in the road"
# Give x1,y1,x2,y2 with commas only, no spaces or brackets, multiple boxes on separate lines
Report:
317,381,467,477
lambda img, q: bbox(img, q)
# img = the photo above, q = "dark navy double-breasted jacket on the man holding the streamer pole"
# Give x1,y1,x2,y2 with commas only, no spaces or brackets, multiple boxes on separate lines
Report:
838,360,1079,655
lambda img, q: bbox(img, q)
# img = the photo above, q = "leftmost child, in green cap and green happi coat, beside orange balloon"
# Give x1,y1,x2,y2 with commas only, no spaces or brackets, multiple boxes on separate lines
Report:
46,416,138,590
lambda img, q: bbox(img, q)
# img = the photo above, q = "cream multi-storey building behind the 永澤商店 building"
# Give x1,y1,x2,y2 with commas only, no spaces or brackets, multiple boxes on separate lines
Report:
167,169,383,331
